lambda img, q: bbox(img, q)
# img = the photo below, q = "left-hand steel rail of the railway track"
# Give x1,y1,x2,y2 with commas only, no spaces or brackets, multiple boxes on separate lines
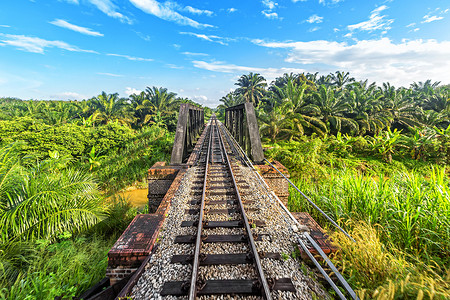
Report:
189,122,214,300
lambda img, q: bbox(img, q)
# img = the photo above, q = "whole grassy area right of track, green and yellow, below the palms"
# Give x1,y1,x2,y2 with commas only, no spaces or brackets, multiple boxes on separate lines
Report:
265,138,450,299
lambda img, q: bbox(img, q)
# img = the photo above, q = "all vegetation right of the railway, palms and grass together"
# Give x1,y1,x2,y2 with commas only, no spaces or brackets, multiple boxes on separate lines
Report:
223,72,450,299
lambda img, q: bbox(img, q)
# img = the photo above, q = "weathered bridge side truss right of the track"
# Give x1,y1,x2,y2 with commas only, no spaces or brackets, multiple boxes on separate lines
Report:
225,103,264,163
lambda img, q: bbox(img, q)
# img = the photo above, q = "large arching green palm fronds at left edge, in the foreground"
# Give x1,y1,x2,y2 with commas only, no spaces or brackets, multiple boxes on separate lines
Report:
0,144,102,243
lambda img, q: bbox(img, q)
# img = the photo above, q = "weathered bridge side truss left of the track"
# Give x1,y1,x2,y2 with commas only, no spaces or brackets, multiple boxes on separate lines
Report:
170,103,205,165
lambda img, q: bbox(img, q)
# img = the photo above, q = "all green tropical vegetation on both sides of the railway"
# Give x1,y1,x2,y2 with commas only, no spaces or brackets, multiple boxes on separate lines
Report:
0,71,450,299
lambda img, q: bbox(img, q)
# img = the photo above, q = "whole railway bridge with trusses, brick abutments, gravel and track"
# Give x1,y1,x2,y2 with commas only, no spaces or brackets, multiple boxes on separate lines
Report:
84,103,356,299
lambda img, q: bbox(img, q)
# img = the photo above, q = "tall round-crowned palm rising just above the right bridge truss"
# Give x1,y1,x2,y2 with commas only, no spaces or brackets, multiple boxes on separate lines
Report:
235,72,267,106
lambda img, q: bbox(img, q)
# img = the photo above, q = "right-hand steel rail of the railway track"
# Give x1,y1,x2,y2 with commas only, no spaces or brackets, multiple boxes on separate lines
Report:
217,120,272,300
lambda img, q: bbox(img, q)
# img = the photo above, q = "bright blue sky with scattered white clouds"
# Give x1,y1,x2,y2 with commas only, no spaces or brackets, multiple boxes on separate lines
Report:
0,0,450,107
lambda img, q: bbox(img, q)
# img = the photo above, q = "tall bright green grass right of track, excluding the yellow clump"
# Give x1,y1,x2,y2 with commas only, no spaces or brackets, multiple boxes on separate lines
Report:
289,167,450,263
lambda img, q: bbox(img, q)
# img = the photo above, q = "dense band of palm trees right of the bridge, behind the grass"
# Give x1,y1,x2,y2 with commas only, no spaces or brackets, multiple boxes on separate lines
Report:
223,71,450,155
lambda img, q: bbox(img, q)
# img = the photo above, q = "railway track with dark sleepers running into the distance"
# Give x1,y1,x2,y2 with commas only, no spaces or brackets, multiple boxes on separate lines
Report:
160,116,296,299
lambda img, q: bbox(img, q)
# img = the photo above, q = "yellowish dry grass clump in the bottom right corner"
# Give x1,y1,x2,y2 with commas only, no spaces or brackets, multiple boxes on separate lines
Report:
333,221,450,300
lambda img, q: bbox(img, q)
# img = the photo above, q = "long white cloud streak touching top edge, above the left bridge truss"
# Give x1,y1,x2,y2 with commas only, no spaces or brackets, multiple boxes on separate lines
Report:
130,0,214,28
